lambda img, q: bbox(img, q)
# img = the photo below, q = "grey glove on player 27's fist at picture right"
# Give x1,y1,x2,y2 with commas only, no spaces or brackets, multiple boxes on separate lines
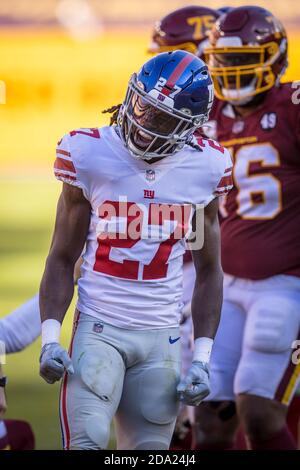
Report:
177,361,210,406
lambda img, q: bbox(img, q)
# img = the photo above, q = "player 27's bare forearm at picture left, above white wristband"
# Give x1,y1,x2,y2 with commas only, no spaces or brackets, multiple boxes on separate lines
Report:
40,254,74,323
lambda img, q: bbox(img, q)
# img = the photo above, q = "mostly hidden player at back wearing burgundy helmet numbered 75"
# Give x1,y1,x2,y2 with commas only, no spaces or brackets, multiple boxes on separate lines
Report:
148,5,222,450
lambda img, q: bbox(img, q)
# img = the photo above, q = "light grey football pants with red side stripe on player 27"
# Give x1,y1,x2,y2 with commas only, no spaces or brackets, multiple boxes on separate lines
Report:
60,313,181,450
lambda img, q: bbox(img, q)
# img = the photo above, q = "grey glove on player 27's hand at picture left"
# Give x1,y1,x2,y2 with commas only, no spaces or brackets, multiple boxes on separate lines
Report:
40,343,74,384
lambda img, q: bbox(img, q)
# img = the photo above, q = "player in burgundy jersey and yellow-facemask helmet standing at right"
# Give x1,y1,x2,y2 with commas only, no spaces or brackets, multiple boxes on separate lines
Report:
191,6,300,449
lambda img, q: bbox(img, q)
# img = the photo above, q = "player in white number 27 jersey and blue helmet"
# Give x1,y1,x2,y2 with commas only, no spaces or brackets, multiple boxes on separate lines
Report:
40,51,231,449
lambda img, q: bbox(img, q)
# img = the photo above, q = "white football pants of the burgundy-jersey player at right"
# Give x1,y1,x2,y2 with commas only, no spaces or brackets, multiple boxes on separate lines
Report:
206,275,300,405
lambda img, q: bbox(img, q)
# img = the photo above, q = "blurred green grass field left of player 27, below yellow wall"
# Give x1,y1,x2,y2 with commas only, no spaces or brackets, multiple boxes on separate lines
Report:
0,176,74,449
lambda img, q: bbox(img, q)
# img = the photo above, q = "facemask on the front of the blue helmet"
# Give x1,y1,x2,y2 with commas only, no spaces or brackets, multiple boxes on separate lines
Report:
118,74,208,160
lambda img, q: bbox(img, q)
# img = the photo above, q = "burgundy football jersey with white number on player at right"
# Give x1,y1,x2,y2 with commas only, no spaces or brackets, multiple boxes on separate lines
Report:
210,83,300,279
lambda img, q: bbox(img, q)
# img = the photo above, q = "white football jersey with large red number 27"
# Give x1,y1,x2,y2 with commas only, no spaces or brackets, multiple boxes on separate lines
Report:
55,126,232,329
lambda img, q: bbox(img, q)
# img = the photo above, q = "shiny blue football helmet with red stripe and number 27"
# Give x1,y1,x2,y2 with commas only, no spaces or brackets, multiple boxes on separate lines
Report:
117,50,214,160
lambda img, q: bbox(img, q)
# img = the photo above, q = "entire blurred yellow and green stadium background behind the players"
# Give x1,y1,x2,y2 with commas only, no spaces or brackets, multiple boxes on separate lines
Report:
0,0,300,449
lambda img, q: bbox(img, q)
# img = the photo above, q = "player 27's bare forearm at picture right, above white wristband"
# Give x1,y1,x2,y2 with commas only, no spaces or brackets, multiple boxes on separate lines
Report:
192,267,223,339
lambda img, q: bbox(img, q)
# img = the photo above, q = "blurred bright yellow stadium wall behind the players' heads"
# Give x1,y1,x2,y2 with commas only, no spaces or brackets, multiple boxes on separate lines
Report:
0,31,300,171
